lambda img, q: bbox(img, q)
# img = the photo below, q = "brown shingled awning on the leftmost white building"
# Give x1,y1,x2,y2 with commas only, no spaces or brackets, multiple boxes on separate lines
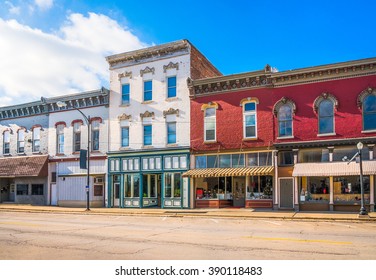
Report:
0,156,48,178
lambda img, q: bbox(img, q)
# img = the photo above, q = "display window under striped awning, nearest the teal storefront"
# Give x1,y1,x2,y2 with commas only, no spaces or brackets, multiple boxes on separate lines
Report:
196,177,232,200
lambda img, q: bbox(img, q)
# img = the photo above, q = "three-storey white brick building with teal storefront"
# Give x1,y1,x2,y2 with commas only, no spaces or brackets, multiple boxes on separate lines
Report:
107,40,221,208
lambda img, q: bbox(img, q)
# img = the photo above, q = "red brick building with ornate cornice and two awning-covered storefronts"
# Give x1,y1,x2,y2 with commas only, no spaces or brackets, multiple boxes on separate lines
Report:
185,59,376,211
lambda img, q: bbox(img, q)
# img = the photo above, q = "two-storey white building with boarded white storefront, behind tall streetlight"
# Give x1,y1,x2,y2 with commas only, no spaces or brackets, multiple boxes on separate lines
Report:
44,88,109,207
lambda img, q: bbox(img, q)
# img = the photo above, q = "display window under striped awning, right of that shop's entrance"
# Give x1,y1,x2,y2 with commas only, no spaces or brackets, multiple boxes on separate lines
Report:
247,176,273,199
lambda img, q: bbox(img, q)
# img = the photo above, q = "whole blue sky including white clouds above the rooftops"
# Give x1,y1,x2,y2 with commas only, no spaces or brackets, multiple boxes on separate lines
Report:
0,0,376,106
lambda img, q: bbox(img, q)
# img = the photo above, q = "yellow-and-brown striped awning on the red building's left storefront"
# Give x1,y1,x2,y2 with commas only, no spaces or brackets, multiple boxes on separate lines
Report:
183,166,274,178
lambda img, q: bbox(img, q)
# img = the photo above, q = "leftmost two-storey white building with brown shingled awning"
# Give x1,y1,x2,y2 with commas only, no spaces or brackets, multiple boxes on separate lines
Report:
0,101,49,205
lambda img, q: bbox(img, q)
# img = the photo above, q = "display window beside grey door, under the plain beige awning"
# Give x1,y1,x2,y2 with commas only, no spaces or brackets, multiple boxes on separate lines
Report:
300,177,330,202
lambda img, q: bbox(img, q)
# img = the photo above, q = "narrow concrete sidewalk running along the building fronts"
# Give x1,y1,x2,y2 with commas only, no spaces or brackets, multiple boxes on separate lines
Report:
0,204,376,222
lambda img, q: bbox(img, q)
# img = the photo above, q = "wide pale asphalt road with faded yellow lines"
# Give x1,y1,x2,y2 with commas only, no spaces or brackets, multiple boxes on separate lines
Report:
0,212,376,260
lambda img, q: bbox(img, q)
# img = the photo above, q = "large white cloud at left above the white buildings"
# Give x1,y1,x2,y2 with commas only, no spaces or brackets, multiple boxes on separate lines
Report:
0,13,147,106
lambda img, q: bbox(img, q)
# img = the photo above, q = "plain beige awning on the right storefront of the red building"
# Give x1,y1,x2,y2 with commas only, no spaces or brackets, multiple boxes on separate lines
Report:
292,160,376,177
